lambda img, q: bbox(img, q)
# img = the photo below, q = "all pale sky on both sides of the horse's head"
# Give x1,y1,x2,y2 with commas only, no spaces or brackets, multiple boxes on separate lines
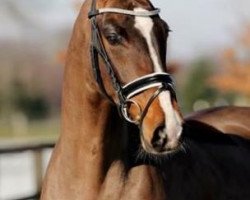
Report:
0,0,250,60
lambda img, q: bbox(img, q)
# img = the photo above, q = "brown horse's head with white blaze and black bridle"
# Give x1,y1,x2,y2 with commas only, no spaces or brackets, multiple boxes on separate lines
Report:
85,0,182,155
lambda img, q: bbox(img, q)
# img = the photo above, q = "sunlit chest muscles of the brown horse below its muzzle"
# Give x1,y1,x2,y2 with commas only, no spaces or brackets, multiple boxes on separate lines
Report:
99,165,166,200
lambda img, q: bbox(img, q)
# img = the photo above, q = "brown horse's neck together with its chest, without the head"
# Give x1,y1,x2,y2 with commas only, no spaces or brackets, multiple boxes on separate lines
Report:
42,1,167,200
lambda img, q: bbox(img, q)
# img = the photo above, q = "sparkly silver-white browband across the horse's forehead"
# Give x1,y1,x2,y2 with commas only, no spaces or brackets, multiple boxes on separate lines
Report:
88,8,160,18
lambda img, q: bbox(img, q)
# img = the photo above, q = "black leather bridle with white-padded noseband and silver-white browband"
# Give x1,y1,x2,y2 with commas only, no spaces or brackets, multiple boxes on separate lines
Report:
88,0,176,125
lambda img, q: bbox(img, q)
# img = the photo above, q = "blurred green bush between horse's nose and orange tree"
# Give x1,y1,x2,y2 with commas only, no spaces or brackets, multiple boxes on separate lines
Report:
181,59,218,113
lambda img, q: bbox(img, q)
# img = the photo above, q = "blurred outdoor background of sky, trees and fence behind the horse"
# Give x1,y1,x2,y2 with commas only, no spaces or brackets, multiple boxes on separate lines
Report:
0,0,250,199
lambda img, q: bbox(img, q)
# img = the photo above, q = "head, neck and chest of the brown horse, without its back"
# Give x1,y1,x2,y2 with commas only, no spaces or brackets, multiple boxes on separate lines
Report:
42,0,182,200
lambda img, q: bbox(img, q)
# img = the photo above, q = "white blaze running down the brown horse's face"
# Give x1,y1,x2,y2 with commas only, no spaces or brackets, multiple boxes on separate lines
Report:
134,8,182,147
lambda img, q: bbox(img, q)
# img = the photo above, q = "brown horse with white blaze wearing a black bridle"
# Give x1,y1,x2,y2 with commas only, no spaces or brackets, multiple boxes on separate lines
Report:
41,0,250,200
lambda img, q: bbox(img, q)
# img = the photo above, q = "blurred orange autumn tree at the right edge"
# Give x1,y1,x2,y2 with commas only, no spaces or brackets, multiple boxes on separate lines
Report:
209,24,250,97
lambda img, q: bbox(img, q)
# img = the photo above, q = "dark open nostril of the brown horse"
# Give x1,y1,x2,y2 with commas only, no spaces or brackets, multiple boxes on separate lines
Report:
151,126,167,152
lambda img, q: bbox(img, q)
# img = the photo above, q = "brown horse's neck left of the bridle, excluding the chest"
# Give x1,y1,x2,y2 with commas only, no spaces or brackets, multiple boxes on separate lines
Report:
44,2,125,199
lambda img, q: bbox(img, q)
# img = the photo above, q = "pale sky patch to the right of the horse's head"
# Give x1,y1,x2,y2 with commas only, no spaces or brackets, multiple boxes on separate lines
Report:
152,0,250,59
